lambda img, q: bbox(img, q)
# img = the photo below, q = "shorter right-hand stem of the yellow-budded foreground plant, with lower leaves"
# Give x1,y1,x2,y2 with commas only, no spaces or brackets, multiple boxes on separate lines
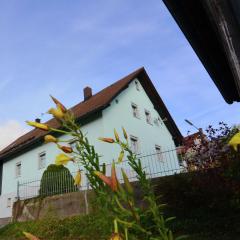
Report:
98,128,186,240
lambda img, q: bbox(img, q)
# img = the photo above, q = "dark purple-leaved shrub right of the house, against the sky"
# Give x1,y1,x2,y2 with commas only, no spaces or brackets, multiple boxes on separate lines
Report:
184,122,240,170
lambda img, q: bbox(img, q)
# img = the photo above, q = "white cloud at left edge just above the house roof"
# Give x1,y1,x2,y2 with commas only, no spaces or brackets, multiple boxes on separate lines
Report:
0,120,28,150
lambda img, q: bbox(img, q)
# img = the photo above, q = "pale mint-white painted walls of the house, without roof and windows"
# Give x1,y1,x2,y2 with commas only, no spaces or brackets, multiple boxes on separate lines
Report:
0,78,178,218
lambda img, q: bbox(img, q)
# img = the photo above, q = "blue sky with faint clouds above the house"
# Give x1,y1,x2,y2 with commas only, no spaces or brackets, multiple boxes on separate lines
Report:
0,0,239,149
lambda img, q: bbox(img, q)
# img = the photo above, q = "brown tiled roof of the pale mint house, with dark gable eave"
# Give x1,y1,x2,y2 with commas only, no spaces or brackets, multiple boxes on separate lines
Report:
0,68,182,160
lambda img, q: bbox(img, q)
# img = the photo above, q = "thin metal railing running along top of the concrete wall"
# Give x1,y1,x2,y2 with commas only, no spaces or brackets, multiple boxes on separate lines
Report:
17,149,186,200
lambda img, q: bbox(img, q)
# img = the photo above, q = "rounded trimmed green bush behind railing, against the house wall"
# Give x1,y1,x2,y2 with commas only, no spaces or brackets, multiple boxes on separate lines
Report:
39,164,78,196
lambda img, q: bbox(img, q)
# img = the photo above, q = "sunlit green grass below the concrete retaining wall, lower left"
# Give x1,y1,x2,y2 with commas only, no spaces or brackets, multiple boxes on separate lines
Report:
0,215,111,240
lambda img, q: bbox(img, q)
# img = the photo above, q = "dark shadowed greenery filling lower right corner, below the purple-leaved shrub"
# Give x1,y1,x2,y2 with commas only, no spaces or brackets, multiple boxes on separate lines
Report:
154,168,240,240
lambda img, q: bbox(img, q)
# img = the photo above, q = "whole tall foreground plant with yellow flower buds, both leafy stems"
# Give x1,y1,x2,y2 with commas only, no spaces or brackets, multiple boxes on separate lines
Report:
25,97,183,240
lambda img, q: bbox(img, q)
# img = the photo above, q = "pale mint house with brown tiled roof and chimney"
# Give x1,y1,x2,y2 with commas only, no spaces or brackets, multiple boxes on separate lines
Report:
0,68,182,222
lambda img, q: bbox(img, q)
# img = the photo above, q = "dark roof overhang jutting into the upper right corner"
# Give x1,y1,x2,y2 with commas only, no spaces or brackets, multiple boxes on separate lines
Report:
163,0,240,103
